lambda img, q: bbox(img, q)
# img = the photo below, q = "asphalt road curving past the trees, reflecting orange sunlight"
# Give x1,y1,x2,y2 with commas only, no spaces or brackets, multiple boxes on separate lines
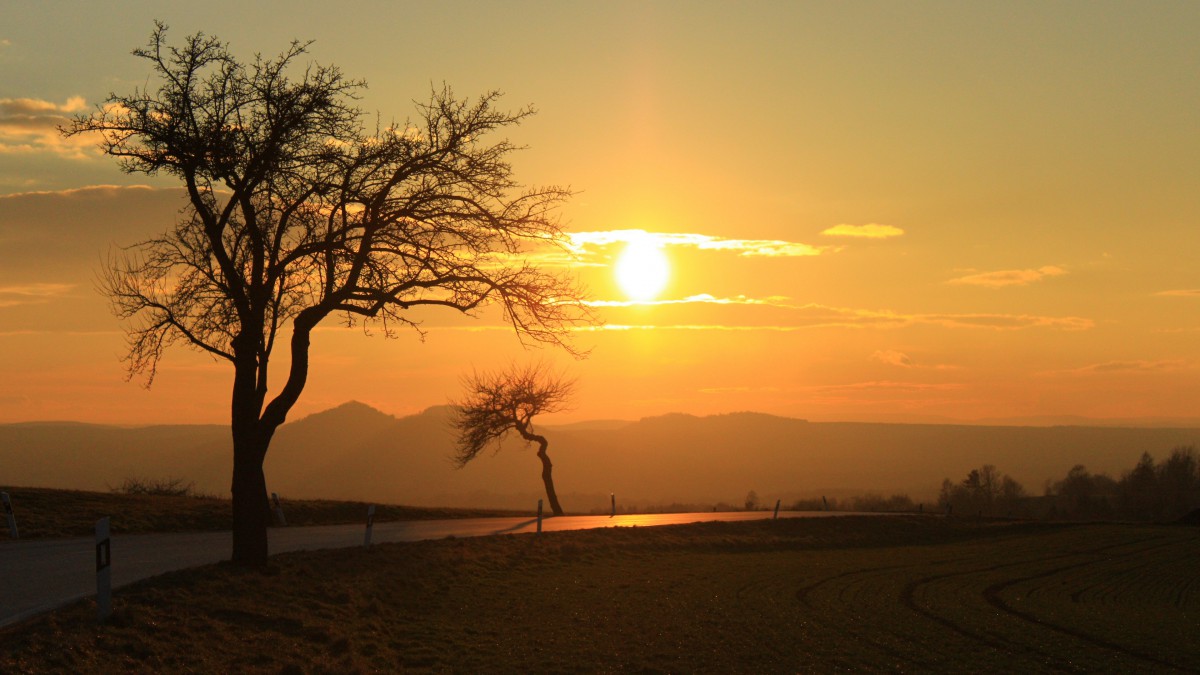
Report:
0,512,845,626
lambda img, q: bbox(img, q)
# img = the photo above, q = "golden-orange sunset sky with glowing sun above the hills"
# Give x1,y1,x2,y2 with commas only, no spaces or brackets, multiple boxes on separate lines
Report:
0,0,1200,424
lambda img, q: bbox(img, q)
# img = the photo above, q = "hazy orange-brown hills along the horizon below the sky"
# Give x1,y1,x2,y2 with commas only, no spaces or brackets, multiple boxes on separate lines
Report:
0,402,1200,510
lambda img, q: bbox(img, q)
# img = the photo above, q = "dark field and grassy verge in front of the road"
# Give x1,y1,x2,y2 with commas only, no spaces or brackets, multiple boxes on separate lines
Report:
0,516,1200,673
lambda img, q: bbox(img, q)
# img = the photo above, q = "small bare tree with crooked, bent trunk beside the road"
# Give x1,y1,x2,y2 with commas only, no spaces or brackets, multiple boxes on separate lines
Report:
451,364,575,515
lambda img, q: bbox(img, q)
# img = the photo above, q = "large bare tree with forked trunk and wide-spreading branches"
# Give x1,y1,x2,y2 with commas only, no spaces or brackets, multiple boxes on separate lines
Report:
64,24,590,566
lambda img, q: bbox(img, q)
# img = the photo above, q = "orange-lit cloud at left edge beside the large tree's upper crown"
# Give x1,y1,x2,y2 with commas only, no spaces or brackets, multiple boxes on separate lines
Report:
0,96,96,159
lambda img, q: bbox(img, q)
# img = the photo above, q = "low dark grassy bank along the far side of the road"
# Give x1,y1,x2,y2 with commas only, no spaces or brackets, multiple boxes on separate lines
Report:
0,488,528,540
